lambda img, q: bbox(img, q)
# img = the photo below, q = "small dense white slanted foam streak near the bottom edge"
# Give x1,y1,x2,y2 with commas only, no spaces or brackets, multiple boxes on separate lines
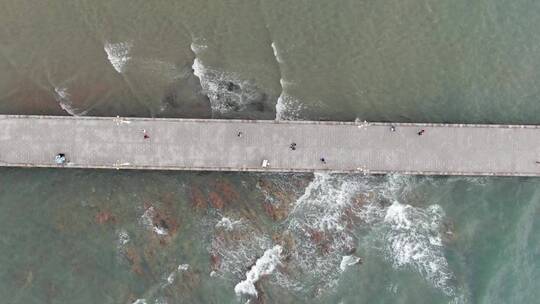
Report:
234,245,283,297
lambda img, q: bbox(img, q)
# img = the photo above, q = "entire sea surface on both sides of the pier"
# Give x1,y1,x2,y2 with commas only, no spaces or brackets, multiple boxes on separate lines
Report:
0,0,540,304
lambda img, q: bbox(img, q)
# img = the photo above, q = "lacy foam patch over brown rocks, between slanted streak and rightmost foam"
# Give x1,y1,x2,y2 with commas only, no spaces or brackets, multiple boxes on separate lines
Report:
280,173,365,295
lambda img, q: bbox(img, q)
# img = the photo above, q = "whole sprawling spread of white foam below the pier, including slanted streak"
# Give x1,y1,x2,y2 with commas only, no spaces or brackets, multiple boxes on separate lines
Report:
210,173,456,296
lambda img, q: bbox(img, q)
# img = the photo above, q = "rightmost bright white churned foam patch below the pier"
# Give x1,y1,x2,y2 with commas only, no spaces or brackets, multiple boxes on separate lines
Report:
360,175,456,296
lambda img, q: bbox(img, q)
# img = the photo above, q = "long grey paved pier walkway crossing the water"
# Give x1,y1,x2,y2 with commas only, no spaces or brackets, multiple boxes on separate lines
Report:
0,115,540,176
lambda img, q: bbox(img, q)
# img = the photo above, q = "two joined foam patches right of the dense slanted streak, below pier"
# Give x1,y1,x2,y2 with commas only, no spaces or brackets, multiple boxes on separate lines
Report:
277,173,455,295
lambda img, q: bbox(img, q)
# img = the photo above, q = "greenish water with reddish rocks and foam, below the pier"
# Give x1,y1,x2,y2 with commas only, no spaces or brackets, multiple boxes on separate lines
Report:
0,169,540,303
